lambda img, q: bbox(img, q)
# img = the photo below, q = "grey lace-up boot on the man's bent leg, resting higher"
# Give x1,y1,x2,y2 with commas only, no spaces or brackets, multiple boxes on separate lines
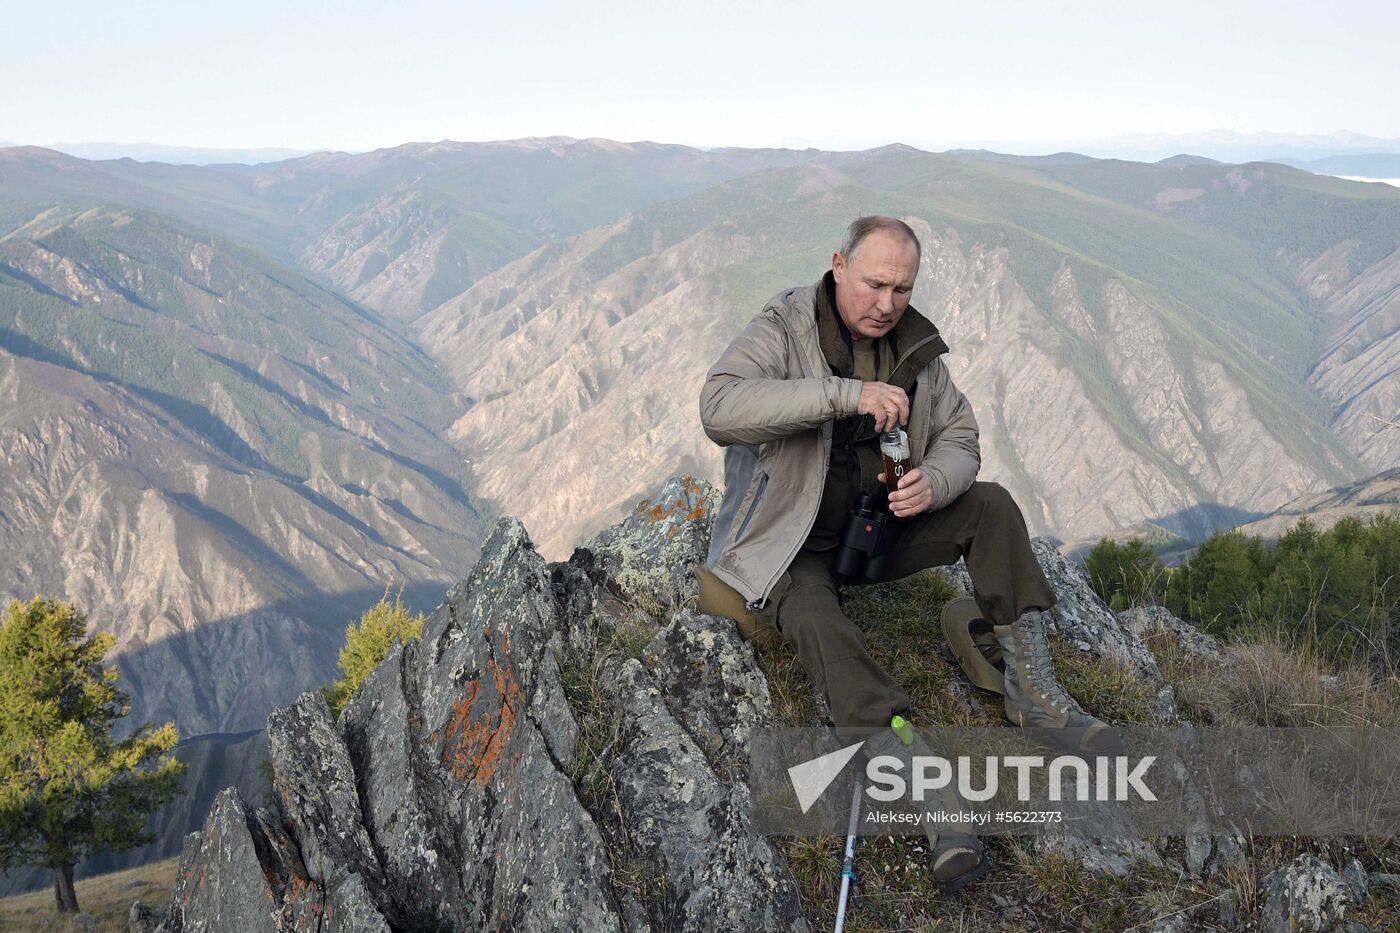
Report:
993,609,1119,755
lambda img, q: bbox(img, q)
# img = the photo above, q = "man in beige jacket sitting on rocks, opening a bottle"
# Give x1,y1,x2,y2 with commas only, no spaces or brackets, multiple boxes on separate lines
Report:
700,216,1109,892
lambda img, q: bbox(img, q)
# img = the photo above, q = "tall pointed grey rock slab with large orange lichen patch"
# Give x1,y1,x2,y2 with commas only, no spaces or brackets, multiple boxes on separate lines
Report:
414,518,619,930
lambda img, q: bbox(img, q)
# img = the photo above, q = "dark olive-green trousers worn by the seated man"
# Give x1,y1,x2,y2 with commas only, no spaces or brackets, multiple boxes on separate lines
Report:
757,482,1054,727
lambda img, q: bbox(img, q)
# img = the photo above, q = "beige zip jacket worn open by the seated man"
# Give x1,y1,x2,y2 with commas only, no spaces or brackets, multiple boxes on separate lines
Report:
700,277,981,609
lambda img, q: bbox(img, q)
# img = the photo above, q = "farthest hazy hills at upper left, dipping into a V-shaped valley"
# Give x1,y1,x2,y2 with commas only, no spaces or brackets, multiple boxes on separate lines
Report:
0,137,820,317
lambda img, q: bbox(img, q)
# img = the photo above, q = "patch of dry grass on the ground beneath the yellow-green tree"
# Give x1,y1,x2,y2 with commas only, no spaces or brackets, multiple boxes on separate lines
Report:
0,859,179,933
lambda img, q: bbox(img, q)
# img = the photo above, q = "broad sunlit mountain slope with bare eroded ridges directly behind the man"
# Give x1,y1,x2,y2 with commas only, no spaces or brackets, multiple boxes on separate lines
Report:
414,148,1364,553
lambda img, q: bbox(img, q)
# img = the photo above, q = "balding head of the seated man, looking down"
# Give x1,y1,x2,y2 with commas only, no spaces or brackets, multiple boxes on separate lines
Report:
832,216,923,340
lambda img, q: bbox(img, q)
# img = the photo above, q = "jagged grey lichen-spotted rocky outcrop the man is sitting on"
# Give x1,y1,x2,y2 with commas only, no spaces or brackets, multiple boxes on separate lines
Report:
142,478,1364,933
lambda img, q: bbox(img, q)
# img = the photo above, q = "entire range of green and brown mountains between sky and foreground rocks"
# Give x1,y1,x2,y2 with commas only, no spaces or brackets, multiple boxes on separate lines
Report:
0,137,1400,735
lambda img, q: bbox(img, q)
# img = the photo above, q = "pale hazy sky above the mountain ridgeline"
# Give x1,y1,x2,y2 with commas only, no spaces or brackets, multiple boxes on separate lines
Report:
0,0,1400,150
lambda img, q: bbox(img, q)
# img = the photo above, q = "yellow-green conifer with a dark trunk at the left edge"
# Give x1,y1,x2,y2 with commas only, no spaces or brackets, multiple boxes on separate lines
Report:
0,597,185,913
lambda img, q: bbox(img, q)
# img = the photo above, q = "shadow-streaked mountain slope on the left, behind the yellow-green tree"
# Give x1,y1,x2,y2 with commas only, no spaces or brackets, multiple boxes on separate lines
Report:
0,210,480,735
